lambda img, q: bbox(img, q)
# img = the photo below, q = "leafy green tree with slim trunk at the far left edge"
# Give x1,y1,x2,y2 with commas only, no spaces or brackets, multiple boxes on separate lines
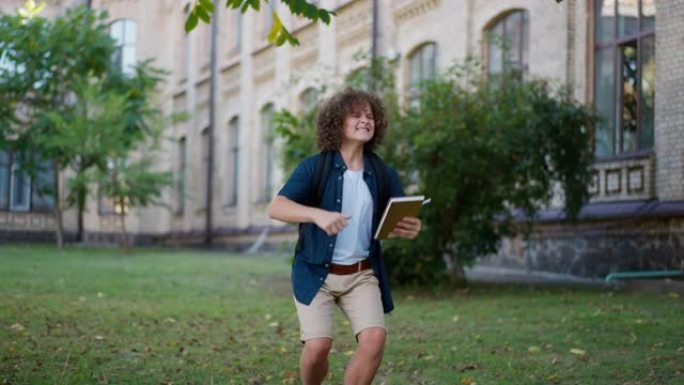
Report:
0,7,114,246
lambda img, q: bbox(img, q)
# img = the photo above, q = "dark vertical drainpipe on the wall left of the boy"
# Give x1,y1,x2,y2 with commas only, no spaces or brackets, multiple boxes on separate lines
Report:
204,0,219,246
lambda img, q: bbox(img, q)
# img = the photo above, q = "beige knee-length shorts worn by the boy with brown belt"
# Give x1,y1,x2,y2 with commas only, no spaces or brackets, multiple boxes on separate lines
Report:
295,269,387,341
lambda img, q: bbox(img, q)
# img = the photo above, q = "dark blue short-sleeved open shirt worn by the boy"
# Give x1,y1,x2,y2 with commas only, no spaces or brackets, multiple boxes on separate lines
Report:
278,152,404,313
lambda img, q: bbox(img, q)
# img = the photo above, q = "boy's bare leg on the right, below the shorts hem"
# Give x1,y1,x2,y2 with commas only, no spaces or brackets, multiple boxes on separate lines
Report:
344,328,387,385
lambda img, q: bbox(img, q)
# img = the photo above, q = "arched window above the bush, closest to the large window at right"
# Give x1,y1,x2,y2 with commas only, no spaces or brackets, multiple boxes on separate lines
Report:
486,10,529,75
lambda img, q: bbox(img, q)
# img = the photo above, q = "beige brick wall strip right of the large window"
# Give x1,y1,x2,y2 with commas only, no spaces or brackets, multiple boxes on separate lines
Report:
655,0,684,200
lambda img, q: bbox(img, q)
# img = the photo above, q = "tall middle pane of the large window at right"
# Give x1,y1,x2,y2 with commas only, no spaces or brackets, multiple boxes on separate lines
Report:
618,42,639,152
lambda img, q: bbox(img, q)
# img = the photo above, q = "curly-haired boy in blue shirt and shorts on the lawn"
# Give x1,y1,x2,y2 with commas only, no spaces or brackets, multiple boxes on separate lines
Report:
268,88,421,385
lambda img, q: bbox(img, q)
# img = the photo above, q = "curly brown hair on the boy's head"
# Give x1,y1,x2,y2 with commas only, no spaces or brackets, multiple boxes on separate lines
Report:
316,88,388,151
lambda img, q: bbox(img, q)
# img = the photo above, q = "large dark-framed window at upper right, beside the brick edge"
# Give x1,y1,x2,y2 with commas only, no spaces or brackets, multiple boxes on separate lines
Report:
594,0,655,158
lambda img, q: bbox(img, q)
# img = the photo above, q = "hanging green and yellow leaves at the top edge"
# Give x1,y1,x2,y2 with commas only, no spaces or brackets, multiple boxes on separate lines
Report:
185,0,335,46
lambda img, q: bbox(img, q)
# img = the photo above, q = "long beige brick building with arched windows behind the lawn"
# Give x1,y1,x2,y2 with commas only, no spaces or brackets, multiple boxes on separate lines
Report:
0,0,684,276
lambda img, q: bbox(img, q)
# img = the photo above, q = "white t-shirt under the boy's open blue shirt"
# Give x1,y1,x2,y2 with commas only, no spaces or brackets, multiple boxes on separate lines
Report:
332,170,373,265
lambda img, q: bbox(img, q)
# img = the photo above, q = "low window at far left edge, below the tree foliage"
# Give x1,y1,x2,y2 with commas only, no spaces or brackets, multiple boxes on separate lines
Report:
0,150,55,212
